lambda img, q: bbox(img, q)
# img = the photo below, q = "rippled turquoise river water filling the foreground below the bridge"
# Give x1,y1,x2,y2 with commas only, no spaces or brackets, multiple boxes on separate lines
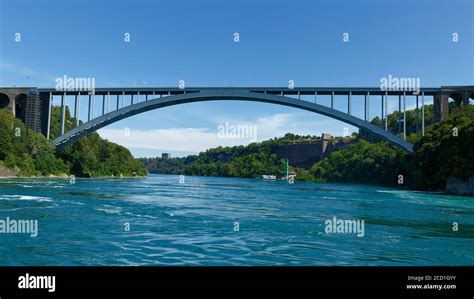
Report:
0,175,474,265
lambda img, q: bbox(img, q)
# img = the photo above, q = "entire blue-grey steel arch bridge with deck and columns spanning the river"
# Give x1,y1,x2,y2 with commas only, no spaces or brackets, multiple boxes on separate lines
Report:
0,86,474,153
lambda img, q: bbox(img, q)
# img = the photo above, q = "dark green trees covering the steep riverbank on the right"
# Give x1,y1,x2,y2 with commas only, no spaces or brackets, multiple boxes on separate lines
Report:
311,106,474,190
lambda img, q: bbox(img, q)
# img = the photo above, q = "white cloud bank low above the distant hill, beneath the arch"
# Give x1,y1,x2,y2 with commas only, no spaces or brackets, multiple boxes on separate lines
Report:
98,113,354,153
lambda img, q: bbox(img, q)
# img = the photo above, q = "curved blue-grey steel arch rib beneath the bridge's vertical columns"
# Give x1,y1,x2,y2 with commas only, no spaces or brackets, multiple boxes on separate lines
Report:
54,89,414,154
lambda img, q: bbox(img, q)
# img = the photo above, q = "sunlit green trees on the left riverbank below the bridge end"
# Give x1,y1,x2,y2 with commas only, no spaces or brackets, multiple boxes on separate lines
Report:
0,107,146,177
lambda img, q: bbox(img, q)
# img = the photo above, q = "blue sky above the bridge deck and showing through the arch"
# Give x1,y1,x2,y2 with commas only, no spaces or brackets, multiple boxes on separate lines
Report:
0,0,474,156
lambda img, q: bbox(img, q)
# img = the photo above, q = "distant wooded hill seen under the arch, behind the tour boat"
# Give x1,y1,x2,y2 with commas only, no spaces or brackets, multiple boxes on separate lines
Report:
140,133,351,179
